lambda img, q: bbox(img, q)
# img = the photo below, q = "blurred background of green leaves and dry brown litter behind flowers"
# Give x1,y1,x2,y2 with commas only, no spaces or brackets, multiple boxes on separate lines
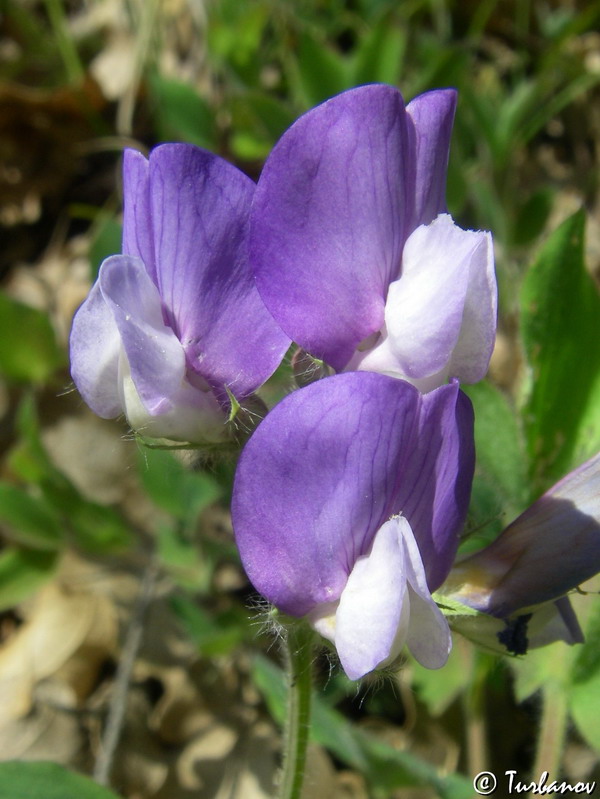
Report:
0,0,600,799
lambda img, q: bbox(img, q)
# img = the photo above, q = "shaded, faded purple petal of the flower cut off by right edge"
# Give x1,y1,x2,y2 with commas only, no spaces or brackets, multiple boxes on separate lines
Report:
444,453,600,618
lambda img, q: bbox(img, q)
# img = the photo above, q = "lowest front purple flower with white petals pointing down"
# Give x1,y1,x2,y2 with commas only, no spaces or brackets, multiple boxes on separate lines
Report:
232,372,474,679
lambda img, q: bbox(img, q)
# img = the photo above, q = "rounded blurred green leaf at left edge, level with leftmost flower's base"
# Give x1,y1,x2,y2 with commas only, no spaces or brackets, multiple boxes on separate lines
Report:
0,292,66,383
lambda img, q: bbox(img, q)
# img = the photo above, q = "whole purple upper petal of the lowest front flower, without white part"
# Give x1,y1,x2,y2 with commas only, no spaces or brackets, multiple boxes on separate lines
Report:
232,372,474,615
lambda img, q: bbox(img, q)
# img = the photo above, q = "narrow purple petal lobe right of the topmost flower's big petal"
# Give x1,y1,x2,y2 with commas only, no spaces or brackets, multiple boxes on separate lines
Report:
406,89,456,230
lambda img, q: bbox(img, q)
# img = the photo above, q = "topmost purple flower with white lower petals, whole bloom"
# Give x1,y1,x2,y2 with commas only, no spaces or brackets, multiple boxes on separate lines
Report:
250,84,496,390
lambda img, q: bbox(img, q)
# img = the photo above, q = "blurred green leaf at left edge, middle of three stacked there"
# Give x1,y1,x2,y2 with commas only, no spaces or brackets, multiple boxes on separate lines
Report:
0,483,64,550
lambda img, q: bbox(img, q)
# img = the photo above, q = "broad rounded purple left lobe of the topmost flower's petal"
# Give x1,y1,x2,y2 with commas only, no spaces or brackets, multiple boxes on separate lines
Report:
250,85,415,370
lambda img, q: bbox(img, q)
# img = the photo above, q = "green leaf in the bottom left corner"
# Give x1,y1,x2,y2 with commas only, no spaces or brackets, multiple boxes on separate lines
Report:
0,760,118,799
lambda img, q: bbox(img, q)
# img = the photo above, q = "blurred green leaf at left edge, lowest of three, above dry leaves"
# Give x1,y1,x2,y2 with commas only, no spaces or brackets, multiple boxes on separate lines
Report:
0,547,58,612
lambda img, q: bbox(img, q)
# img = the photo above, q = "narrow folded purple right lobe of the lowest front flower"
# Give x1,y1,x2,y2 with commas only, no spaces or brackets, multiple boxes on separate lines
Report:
396,382,475,591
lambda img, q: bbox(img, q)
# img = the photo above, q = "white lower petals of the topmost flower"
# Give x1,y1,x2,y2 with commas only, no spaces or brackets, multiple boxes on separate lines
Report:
349,214,496,391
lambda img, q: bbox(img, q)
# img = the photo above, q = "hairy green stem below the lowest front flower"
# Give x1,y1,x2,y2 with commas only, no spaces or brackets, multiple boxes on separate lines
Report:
279,624,312,799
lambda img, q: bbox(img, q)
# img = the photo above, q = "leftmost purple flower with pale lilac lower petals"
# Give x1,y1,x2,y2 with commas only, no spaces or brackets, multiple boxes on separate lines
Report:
71,144,289,442
